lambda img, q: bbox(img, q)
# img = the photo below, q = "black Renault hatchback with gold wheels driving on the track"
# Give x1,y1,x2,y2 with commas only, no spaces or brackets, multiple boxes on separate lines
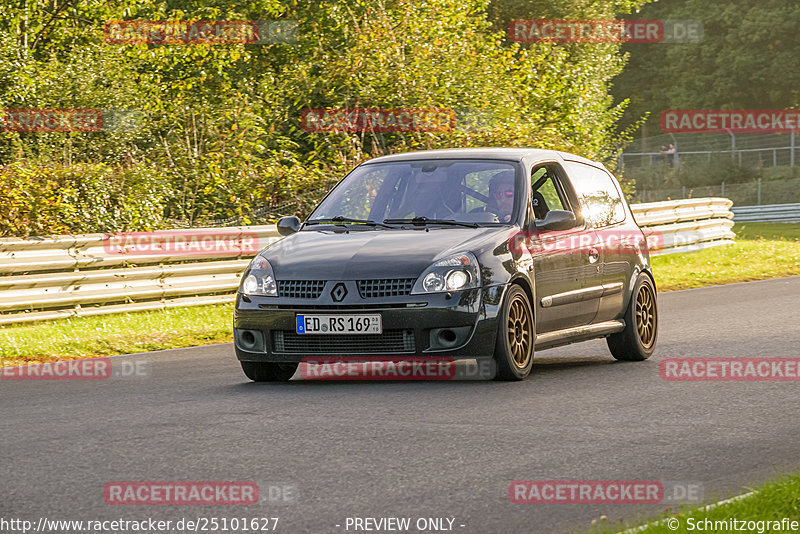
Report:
234,149,658,381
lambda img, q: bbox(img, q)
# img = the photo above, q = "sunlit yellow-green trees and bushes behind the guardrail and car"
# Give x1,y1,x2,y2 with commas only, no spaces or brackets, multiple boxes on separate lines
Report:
0,0,646,231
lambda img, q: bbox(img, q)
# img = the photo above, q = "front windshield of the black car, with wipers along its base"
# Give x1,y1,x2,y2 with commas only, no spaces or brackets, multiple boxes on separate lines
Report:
309,160,516,226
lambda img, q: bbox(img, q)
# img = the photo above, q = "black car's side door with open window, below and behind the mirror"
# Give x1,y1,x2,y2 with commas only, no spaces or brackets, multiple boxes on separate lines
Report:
529,163,602,333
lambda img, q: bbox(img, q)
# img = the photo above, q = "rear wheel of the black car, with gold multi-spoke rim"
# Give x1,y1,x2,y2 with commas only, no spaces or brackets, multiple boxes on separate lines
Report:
606,273,658,362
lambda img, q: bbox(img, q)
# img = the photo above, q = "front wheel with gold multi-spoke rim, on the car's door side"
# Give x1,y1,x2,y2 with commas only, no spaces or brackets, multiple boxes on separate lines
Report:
494,284,536,380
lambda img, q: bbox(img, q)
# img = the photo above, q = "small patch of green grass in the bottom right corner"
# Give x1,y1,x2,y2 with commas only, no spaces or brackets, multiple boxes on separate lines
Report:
590,473,800,534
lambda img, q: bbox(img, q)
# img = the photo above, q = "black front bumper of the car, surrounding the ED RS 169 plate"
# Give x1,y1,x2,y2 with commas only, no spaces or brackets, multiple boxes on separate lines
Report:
233,281,506,362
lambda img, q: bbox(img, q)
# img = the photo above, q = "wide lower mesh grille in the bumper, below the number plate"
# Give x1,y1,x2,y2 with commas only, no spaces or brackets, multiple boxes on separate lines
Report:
272,330,415,354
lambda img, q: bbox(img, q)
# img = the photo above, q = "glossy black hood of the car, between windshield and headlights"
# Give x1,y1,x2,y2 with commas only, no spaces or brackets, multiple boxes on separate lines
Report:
262,227,510,280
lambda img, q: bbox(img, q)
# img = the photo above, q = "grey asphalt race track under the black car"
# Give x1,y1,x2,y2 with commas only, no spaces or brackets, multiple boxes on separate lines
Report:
0,277,800,534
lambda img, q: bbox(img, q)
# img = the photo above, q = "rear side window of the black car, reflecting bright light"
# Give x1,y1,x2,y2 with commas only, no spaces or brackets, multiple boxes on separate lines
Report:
567,161,625,228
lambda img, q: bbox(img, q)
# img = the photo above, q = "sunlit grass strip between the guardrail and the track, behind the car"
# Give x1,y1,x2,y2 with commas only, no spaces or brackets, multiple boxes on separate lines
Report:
0,223,800,366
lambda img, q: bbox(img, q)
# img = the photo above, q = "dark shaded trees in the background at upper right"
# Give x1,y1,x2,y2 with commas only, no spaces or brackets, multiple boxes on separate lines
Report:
614,0,800,131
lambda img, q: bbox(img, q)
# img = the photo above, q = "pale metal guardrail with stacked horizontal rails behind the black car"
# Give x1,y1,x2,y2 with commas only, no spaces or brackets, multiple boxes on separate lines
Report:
0,198,733,325
